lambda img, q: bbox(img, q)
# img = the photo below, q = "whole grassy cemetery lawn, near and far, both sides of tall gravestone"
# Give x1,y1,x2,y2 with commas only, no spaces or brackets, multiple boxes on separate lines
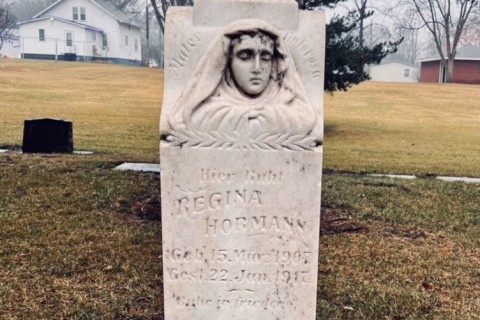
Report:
0,59,480,320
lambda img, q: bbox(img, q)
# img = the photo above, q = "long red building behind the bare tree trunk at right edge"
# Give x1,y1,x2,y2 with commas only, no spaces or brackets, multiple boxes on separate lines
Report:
419,47,480,84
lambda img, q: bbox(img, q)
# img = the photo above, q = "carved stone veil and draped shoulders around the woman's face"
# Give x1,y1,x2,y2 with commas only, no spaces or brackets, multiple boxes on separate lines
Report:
168,19,316,137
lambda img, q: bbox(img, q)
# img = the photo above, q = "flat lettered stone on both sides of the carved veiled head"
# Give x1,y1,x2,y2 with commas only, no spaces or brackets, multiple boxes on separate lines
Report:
160,7,325,140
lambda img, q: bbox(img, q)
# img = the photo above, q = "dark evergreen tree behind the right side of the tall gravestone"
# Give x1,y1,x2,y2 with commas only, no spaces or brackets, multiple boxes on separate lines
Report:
297,0,402,92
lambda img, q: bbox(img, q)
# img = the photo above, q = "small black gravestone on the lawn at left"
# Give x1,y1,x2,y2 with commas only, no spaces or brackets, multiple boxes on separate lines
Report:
22,118,73,153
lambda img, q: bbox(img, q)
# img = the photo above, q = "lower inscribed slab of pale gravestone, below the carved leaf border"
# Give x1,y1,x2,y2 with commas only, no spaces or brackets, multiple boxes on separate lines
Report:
160,145,322,320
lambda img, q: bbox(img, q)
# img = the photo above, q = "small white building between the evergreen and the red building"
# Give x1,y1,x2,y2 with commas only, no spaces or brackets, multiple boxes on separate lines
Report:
369,61,420,82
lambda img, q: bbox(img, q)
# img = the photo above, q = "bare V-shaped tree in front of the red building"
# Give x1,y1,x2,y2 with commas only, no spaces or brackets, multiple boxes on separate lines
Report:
406,0,479,82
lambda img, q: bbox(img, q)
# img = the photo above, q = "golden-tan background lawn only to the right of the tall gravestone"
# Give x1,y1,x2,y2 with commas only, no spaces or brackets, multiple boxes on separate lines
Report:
325,82,480,176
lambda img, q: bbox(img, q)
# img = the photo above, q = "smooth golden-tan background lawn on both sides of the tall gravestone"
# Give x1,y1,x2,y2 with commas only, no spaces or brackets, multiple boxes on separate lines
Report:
0,59,480,176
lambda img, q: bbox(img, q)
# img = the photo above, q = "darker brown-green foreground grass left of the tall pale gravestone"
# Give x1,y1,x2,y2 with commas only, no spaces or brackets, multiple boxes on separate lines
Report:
0,154,162,319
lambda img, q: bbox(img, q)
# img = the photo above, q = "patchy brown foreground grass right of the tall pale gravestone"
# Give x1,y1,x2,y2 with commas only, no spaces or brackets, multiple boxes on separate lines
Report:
318,174,480,320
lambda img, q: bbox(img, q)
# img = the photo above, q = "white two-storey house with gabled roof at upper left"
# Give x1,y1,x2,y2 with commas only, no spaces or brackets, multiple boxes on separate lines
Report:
17,0,142,64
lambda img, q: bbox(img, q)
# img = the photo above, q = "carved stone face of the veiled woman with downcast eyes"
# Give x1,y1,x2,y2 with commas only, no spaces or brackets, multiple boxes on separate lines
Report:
230,34,274,96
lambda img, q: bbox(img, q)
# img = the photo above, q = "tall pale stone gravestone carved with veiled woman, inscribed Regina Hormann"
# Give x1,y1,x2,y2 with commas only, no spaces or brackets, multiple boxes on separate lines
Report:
160,0,325,320
